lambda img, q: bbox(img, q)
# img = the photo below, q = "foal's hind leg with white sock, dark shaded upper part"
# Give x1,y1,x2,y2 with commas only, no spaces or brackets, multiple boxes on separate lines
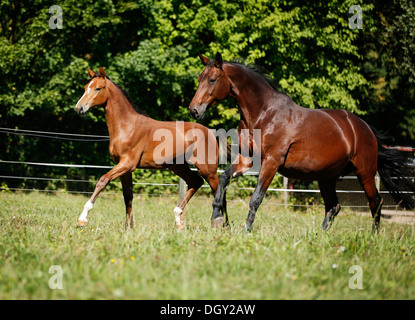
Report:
169,165,203,230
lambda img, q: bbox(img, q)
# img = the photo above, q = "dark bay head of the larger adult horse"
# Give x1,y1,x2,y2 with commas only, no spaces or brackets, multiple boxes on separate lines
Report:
189,52,231,119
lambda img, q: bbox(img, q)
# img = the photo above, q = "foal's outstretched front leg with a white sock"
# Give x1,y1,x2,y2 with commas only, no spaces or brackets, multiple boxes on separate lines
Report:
78,162,132,227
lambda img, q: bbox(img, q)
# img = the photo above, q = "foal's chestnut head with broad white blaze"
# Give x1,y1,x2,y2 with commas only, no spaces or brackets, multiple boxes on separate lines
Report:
76,67,108,115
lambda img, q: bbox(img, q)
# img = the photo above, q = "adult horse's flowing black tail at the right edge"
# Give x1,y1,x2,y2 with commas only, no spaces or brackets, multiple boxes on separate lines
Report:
372,128,415,209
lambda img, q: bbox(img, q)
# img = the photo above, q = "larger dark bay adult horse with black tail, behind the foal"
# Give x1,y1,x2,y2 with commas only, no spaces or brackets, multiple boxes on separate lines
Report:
189,52,415,231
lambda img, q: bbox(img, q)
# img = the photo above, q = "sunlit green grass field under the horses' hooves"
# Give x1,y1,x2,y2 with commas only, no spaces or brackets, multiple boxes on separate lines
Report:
0,193,415,300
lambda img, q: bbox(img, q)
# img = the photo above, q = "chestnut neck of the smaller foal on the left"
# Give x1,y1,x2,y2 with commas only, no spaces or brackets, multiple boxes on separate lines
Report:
105,81,144,139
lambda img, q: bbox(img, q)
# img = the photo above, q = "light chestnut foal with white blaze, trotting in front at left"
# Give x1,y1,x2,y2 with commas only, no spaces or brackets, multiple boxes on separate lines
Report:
76,67,224,229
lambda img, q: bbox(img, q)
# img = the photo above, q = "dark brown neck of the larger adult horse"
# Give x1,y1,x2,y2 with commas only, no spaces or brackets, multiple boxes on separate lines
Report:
229,66,282,128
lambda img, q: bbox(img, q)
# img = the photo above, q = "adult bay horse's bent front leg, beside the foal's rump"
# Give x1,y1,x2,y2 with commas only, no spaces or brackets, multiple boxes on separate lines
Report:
211,154,253,227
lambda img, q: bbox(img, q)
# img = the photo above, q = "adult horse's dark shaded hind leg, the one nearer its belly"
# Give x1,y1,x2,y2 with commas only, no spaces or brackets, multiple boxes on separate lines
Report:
318,178,340,230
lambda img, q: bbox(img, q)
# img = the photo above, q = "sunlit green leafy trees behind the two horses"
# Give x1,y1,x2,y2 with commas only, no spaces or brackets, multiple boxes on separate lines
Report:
0,0,415,191
